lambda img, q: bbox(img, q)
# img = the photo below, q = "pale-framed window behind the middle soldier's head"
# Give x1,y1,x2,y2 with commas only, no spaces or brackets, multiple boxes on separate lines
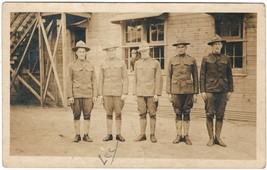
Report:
123,18,165,72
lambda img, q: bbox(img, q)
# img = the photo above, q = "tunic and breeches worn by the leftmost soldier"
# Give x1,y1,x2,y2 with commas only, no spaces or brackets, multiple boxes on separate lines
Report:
67,60,97,120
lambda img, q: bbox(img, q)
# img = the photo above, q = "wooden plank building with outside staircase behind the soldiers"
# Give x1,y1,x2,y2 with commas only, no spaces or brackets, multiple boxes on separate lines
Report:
11,13,257,121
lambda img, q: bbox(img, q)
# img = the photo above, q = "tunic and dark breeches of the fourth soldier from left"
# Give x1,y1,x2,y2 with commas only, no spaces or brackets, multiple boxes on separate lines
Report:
166,54,199,121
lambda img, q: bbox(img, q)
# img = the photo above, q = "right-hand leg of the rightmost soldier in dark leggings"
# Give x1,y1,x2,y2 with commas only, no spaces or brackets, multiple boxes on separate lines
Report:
214,93,227,147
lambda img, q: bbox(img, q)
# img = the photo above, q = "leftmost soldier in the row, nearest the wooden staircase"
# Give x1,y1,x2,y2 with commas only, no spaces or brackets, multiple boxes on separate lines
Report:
67,41,97,142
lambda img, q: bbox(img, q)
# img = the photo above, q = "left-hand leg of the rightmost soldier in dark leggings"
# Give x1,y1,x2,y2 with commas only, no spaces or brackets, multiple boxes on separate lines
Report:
205,93,215,146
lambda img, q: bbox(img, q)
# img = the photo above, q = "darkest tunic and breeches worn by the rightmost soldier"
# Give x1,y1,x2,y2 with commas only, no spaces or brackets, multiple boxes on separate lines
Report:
200,53,234,119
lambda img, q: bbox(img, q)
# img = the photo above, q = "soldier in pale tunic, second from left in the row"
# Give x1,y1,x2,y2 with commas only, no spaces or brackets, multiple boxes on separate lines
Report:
98,44,128,142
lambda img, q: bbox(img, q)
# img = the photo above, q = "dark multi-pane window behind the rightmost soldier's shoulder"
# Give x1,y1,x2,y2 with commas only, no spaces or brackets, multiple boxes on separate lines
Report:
215,14,244,69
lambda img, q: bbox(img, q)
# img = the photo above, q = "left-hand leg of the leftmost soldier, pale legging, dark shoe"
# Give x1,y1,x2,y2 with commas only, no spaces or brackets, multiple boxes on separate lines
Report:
72,98,81,142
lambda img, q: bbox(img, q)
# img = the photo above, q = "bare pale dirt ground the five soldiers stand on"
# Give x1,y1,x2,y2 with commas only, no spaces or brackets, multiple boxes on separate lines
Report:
10,105,256,160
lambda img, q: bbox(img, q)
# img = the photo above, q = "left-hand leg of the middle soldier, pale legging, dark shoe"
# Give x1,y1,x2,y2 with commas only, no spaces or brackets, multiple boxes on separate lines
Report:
135,96,147,141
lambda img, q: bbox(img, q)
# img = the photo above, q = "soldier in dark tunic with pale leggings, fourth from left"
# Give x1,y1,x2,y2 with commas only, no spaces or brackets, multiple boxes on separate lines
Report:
166,39,199,145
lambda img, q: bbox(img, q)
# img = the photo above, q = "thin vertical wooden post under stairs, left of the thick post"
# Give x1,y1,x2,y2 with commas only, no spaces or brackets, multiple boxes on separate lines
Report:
38,13,44,106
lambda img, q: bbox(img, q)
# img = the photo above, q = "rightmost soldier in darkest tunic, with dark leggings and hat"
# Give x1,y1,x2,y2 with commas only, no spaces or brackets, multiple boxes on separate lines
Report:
200,35,234,147
